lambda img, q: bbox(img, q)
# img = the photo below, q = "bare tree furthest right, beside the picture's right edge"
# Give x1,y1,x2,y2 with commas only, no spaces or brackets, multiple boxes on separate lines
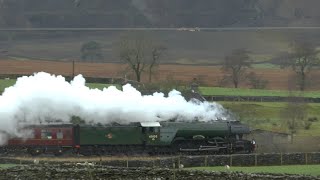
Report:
279,42,319,91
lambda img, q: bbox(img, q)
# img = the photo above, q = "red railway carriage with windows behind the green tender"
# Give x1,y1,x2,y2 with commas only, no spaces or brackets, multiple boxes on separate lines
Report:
6,124,74,154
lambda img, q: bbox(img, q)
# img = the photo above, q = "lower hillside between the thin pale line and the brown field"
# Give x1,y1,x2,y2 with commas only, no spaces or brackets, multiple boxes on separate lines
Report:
0,30,320,66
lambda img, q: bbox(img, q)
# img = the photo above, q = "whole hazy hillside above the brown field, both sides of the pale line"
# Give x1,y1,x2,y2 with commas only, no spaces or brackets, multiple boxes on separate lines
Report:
0,0,320,66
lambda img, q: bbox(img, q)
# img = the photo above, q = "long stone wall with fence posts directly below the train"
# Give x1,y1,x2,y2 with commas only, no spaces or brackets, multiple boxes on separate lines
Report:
0,152,320,168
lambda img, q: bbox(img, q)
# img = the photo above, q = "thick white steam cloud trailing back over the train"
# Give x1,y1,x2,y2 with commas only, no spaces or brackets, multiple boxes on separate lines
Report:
0,72,225,144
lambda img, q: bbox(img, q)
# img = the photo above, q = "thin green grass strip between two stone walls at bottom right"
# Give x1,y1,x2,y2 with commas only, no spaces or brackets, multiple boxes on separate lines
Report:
190,165,320,176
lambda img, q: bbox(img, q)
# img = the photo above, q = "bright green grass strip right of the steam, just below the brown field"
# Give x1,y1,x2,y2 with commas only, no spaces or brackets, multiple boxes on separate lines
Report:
199,87,320,98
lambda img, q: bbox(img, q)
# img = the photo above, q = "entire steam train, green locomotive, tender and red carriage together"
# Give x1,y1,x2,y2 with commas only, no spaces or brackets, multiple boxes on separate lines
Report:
0,121,254,155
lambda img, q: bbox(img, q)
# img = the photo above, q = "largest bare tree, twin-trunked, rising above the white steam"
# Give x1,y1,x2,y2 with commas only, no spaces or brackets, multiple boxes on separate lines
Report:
118,33,165,82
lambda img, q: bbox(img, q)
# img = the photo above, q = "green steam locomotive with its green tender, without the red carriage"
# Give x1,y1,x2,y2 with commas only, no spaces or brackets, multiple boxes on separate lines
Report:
73,121,254,155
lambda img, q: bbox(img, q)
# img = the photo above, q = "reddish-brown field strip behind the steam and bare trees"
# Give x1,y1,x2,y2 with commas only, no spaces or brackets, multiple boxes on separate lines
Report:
0,60,320,90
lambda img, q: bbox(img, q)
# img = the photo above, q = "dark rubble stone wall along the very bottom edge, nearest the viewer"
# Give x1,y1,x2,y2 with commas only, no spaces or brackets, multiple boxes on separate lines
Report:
0,163,320,180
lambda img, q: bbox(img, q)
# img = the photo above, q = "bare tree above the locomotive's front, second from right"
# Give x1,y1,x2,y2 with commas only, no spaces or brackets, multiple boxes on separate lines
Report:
222,49,252,88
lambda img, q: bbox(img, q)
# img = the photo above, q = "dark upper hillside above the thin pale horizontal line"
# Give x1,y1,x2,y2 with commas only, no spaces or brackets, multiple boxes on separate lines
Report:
0,0,320,28
